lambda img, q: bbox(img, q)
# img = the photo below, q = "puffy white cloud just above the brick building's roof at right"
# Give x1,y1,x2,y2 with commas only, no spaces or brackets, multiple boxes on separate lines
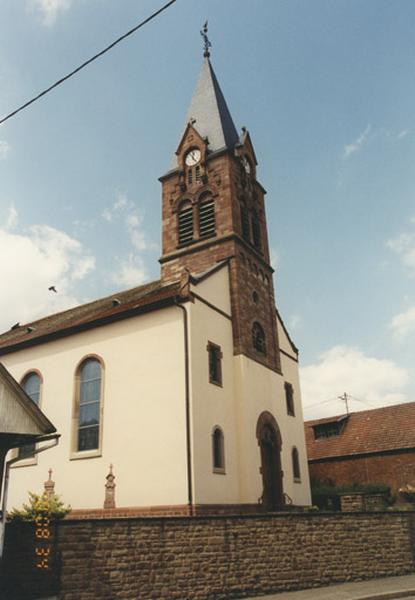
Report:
301,346,409,419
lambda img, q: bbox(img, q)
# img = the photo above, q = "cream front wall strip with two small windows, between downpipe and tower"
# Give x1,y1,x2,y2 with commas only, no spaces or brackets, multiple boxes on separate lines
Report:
187,278,239,504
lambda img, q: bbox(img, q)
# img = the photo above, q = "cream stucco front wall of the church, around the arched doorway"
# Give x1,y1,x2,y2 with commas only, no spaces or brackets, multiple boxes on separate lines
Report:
188,268,310,505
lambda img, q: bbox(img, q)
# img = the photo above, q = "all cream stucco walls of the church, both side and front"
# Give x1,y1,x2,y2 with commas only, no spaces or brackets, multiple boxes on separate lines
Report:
2,266,310,509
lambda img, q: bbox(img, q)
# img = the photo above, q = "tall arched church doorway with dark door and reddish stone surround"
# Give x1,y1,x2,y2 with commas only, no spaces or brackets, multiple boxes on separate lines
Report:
256,411,284,509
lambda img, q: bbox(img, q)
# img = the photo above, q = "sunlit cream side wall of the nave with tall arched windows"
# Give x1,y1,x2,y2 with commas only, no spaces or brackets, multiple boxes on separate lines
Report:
2,307,187,508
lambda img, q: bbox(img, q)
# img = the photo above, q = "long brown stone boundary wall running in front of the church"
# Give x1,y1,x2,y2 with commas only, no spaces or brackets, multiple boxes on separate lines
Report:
0,512,415,600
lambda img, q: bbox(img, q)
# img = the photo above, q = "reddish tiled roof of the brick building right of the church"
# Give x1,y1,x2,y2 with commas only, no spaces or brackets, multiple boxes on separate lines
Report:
304,402,415,460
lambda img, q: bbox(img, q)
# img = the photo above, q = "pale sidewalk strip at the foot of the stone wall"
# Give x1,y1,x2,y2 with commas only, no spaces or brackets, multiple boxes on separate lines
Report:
240,574,415,600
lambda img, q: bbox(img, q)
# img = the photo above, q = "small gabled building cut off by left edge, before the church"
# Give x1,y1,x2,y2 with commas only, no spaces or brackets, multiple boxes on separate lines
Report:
0,363,58,555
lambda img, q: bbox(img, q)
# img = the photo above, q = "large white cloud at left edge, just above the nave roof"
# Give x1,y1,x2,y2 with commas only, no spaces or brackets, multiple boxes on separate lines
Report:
0,213,95,331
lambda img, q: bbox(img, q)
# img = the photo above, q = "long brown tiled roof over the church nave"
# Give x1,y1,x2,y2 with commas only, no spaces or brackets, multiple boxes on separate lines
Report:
0,281,179,355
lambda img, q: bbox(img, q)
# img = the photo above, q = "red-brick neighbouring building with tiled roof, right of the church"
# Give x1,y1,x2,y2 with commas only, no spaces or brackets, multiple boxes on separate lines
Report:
305,402,415,494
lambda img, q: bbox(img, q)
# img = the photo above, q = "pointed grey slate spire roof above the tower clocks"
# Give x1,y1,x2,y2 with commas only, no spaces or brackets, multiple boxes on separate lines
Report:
187,56,239,152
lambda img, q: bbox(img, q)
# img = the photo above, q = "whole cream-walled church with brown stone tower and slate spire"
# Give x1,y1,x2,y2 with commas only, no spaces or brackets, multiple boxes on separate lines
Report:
0,38,310,515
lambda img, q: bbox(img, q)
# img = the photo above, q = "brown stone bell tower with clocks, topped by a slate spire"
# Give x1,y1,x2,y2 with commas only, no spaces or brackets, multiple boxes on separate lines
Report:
160,35,281,372
